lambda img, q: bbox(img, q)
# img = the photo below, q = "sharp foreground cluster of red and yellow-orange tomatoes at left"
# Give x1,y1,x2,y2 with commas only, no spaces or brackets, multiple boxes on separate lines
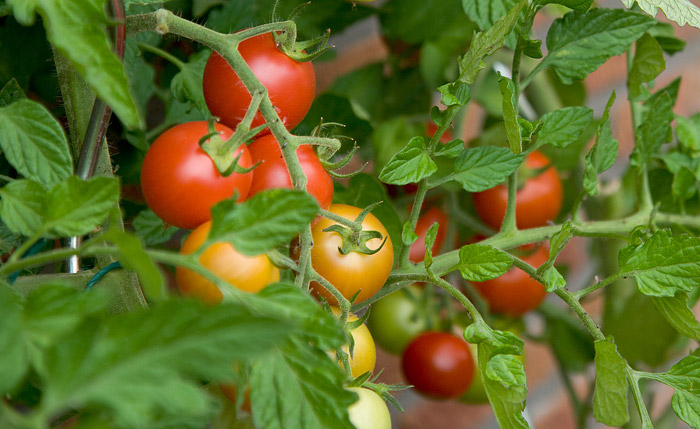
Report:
141,33,394,427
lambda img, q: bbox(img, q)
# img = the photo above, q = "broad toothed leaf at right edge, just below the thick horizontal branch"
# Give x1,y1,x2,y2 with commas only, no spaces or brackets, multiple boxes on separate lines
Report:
616,231,700,297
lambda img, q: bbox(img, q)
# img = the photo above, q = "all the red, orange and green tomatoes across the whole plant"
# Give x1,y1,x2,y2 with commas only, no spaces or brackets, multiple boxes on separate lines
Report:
135,29,562,427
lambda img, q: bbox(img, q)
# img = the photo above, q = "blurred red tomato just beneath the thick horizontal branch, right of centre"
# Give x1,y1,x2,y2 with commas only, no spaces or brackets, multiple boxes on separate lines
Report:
474,245,549,317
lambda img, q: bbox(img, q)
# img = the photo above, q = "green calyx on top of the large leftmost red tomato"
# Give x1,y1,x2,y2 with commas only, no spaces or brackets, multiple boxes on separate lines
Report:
198,119,265,177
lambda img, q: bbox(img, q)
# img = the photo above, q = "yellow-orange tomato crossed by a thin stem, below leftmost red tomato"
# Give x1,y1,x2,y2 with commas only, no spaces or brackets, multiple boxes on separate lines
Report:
175,222,280,304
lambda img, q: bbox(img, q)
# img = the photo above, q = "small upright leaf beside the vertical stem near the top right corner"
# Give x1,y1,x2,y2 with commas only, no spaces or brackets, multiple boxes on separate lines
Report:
627,33,666,100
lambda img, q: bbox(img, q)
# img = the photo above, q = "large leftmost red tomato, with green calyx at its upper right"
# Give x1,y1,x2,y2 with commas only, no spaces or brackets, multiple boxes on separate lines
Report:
141,121,253,229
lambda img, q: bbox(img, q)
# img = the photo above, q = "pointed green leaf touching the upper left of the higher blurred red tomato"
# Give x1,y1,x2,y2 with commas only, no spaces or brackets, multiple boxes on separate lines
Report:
454,146,523,192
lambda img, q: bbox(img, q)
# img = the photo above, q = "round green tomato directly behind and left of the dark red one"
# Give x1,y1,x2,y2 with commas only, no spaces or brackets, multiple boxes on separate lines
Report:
367,286,437,355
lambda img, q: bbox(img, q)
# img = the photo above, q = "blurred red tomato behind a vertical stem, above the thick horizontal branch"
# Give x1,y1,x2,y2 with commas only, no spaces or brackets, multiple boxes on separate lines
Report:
472,151,563,230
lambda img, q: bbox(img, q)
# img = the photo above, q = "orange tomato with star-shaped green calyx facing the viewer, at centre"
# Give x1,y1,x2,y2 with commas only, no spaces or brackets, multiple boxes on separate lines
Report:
311,204,394,305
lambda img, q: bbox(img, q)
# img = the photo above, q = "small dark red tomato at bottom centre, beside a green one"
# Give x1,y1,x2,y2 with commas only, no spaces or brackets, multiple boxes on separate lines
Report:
401,331,474,399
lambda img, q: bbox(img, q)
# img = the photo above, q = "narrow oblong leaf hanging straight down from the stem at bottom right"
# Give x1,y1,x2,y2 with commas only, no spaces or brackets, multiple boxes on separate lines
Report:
593,340,629,426
